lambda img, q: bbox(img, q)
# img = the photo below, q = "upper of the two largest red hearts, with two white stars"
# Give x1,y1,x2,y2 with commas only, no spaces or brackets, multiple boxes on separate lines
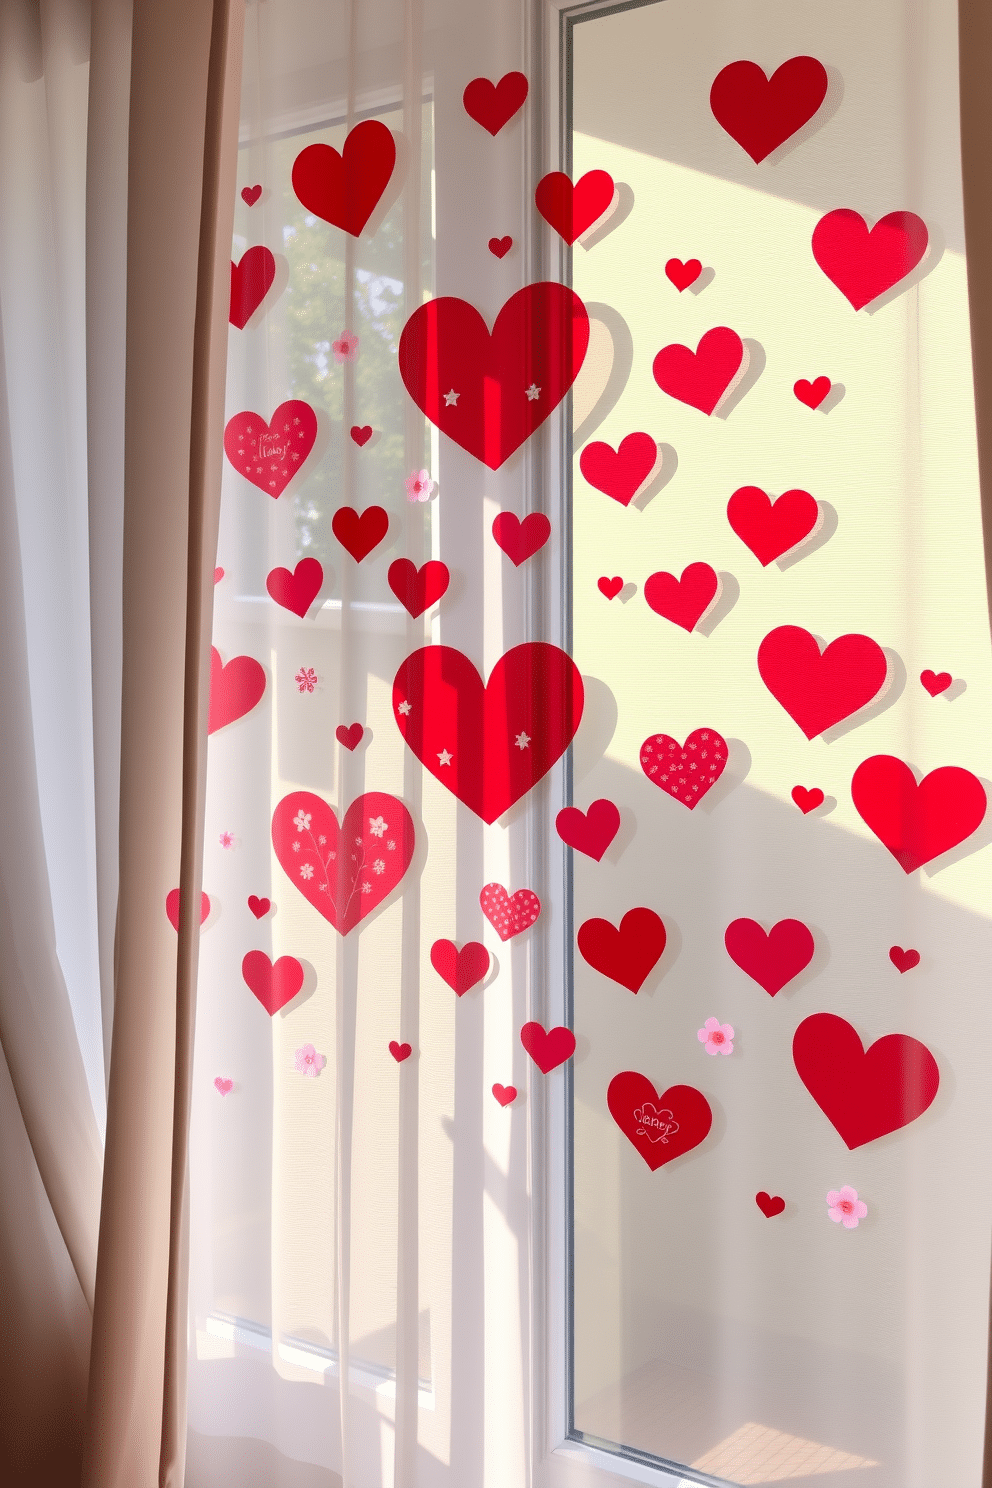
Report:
399,283,589,470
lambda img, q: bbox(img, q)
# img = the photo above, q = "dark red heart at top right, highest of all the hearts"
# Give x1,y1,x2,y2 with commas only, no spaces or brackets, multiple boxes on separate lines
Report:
709,57,828,165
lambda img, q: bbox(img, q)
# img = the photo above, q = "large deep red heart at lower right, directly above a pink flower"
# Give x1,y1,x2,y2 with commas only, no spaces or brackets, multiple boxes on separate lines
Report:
793,1013,940,1152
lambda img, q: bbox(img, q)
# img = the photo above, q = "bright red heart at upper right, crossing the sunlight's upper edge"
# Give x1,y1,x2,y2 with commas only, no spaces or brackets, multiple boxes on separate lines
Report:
812,207,930,310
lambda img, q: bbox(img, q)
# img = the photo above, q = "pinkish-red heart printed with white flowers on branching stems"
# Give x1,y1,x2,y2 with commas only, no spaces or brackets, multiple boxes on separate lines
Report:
272,790,413,934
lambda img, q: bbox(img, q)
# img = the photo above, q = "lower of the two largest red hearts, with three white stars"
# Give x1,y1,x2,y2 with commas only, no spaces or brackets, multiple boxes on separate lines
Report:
393,641,583,823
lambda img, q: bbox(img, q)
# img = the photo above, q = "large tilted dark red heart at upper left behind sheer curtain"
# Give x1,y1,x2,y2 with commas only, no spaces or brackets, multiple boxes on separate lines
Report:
293,119,396,238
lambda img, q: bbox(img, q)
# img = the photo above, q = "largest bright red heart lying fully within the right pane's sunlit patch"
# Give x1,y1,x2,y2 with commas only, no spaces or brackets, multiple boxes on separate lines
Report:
759,625,888,740
